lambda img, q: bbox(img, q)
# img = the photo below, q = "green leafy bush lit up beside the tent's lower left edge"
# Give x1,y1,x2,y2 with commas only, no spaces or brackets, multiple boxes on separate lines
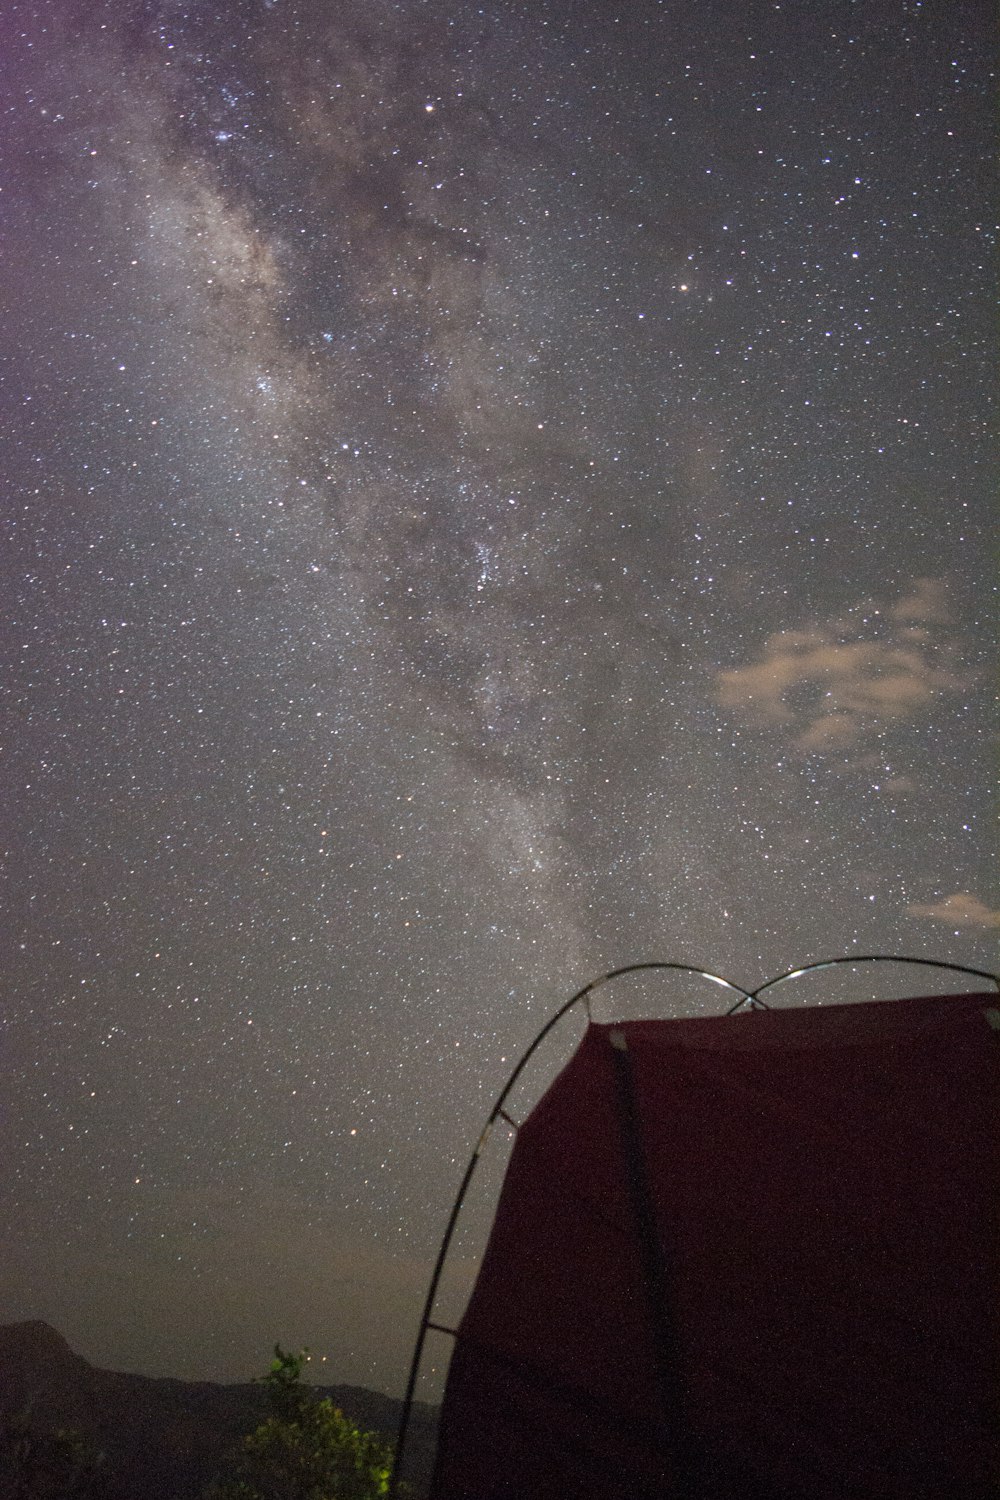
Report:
208,1344,393,1500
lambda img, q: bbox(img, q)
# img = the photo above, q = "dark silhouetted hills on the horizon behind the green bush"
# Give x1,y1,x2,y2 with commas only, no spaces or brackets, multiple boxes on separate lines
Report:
0,1323,438,1500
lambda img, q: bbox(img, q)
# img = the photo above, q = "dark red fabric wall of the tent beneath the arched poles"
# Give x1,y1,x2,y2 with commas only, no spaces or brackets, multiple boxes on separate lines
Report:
430,995,1000,1500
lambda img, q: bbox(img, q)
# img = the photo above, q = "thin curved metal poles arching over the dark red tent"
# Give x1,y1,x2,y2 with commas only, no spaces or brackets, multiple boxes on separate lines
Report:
388,953,1000,1500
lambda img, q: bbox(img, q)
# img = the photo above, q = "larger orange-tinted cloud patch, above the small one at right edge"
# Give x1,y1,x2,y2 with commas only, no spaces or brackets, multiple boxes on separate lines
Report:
715,579,970,752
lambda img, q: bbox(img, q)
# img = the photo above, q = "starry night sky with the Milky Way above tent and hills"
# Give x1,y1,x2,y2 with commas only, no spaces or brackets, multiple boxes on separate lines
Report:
0,0,1000,1391
